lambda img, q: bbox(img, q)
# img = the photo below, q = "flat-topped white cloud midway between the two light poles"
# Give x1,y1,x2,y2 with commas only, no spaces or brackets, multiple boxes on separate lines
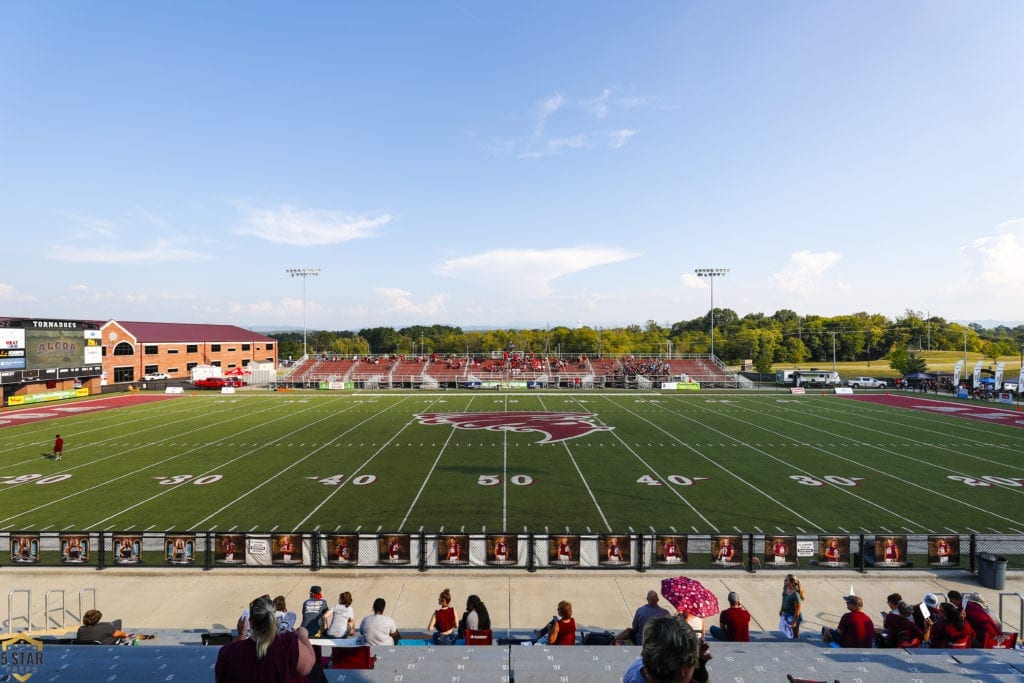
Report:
435,247,640,298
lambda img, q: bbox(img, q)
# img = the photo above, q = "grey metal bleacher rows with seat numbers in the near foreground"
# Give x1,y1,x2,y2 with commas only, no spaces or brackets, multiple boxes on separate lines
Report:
32,639,1024,683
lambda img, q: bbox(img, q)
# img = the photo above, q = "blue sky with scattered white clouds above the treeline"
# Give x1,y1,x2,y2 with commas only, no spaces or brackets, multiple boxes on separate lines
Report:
0,0,1024,330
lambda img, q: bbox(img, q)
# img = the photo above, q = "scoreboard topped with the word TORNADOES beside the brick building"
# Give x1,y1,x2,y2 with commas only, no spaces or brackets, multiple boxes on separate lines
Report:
0,318,103,384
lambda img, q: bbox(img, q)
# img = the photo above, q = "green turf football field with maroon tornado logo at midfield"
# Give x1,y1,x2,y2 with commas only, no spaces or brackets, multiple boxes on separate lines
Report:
0,391,1024,535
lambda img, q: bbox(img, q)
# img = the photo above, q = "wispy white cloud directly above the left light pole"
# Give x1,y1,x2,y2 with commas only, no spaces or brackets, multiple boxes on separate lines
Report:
236,204,391,247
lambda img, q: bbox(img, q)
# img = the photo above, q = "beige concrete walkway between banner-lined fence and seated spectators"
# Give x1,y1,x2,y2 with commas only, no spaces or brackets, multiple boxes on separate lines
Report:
8,567,1024,639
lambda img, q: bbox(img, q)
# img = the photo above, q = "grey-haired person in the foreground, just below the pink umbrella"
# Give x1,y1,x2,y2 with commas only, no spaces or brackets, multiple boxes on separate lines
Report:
623,616,712,683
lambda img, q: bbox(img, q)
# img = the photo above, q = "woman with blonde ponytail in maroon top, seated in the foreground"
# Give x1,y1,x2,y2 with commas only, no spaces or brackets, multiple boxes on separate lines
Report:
214,596,316,683
